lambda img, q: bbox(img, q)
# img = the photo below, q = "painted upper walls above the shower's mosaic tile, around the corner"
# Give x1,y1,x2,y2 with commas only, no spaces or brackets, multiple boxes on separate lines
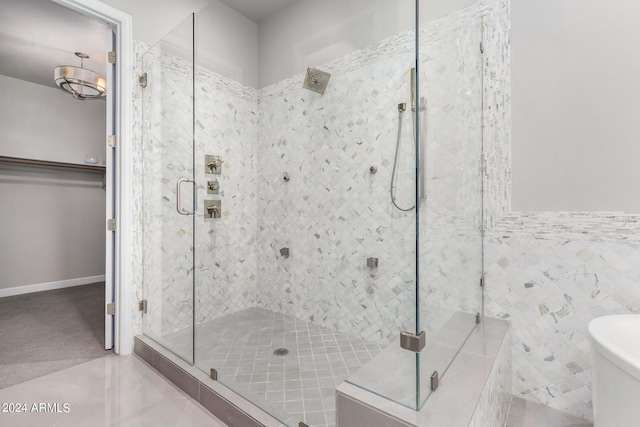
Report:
105,0,476,88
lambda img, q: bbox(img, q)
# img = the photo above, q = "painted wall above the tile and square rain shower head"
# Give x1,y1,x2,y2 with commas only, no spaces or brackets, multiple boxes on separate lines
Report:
258,0,414,88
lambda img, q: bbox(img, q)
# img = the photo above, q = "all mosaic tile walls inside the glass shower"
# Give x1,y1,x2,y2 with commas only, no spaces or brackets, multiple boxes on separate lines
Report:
136,3,493,390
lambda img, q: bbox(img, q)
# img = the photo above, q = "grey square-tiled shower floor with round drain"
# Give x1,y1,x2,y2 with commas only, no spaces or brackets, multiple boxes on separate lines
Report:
164,308,382,427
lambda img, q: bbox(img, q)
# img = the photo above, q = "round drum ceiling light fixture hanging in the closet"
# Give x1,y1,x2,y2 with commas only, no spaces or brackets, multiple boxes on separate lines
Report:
54,52,107,101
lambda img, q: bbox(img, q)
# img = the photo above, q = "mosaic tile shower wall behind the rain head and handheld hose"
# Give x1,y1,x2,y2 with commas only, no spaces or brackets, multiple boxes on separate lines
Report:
258,34,415,344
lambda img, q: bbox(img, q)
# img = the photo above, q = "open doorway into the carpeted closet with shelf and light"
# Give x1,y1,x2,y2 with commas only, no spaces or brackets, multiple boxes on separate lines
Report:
0,1,130,386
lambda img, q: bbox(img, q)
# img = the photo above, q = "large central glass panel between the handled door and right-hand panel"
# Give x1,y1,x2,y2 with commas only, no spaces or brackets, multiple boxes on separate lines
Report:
190,0,417,427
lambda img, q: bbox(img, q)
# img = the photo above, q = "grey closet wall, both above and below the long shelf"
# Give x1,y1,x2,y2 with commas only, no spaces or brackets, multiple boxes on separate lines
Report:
0,76,105,290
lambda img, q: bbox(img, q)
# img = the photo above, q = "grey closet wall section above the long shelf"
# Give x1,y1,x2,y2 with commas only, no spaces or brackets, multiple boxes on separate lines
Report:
0,71,106,163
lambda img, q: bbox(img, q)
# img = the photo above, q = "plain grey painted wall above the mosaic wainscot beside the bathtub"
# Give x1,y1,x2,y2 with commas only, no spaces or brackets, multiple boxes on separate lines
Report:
512,0,640,211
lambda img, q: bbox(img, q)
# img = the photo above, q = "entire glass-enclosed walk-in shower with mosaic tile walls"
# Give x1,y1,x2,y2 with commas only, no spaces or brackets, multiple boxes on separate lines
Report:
140,0,484,426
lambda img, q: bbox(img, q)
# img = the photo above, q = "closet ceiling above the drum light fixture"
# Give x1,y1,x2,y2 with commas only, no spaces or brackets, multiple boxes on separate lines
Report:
0,0,108,87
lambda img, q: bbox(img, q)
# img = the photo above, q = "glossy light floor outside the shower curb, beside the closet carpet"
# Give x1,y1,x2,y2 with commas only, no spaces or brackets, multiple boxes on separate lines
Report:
0,356,226,427
